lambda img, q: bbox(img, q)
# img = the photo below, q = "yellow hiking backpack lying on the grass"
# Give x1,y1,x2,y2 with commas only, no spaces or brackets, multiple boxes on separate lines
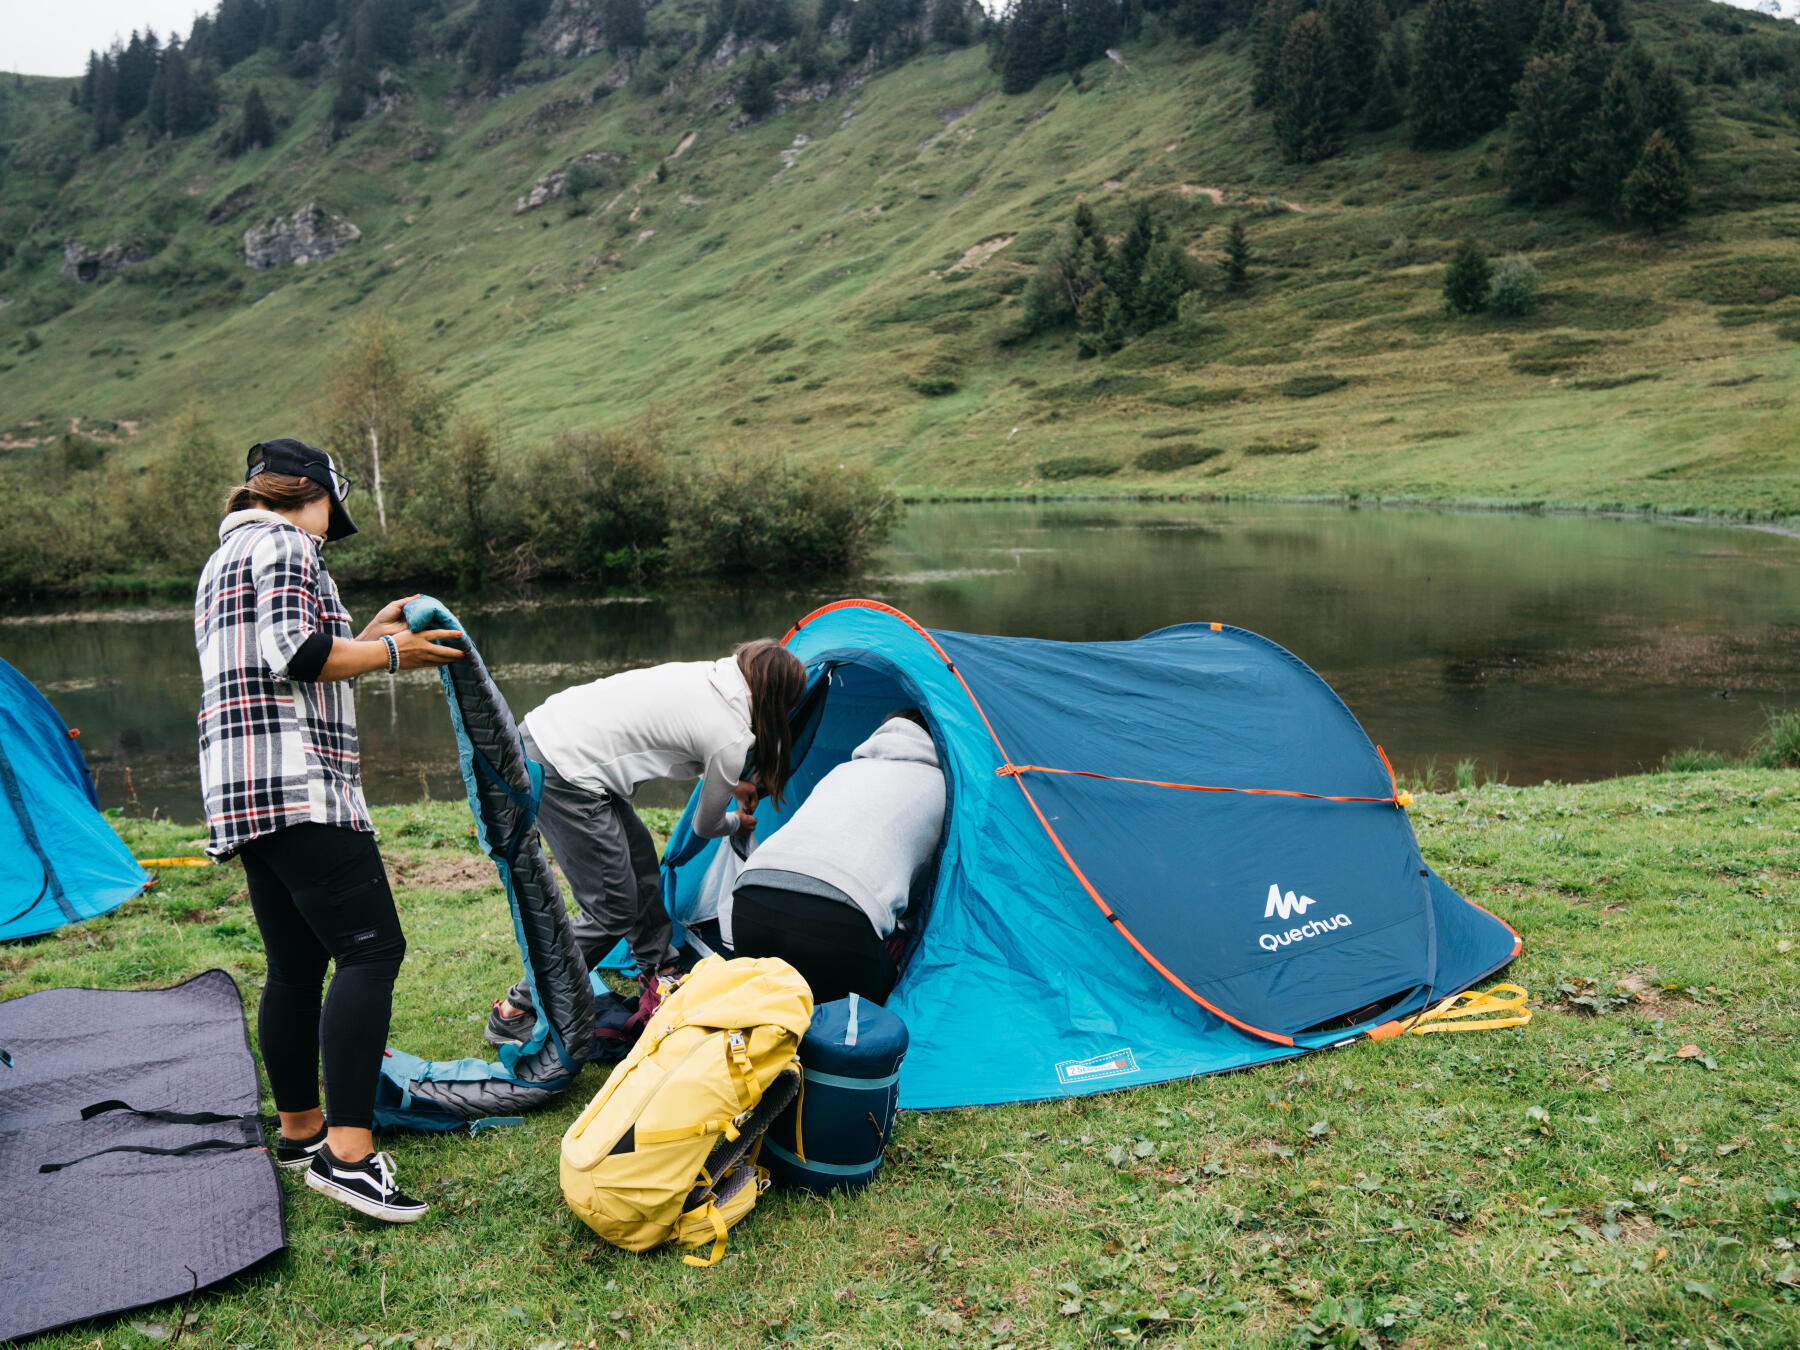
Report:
562,956,812,1265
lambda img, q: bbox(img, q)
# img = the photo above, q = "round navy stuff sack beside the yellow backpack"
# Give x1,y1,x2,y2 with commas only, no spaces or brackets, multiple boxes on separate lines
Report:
761,994,907,1195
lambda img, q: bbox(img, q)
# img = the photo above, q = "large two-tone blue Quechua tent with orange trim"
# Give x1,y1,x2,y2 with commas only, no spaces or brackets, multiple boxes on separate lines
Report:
664,599,1519,1109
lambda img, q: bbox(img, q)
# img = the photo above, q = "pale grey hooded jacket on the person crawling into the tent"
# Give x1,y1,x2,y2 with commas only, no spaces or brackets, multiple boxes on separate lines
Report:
738,718,945,938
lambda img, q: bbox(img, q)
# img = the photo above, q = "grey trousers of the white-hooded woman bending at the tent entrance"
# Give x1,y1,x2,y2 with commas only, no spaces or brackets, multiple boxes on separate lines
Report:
506,733,675,1008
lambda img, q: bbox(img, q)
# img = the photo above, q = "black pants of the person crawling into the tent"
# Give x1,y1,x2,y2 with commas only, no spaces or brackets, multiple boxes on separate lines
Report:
731,886,895,1006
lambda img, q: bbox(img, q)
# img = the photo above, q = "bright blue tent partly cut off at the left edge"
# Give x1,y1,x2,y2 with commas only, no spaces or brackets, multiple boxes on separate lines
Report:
0,661,149,940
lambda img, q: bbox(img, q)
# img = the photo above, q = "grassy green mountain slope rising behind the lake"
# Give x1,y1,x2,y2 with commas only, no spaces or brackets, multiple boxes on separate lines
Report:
0,0,1800,515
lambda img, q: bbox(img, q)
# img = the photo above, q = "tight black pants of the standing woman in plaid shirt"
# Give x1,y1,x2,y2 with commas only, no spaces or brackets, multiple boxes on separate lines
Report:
239,823,407,1129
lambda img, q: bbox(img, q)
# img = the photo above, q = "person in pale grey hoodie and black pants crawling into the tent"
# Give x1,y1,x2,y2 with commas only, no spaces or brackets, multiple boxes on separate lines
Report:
731,709,945,1003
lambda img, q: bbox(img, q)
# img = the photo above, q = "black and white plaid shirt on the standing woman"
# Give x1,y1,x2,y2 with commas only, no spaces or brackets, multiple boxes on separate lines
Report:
194,511,374,857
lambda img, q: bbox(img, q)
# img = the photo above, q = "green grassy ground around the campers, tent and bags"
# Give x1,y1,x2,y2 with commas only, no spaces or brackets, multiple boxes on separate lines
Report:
0,767,1800,1350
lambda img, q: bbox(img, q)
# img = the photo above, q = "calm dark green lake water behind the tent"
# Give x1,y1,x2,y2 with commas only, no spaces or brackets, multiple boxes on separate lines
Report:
0,502,1800,821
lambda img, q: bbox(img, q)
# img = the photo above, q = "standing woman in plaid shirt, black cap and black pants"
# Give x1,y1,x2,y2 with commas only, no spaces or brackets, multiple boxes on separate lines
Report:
194,439,463,1222
